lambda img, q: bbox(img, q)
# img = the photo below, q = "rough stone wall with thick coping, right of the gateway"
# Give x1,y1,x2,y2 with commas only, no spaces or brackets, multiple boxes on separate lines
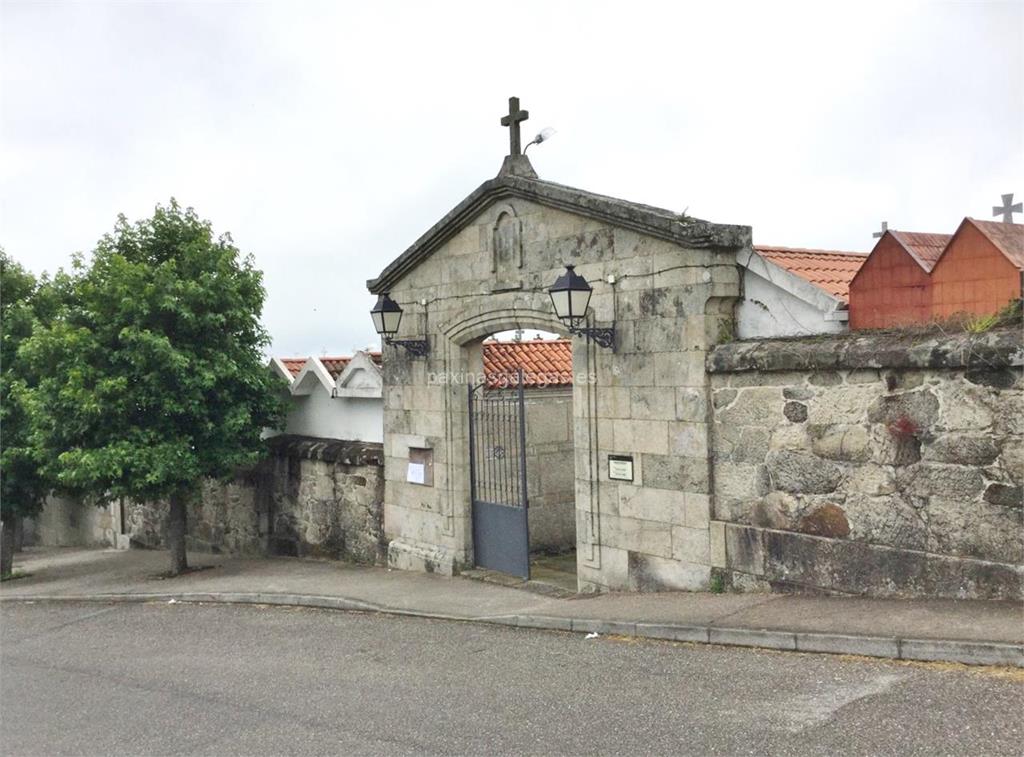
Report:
708,329,1024,598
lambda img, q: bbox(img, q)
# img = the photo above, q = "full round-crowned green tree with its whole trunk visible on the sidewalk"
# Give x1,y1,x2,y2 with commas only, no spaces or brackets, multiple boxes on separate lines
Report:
19,199,282,575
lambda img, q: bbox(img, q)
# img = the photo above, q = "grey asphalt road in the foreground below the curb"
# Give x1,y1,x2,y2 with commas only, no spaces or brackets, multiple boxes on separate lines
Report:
0,603,1024,757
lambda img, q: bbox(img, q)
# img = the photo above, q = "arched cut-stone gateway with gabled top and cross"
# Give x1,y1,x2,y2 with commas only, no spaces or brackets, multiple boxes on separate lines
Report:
369,96,751,591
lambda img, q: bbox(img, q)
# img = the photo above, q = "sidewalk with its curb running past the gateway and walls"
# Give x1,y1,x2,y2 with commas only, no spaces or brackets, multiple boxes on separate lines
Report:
0,549,1024,667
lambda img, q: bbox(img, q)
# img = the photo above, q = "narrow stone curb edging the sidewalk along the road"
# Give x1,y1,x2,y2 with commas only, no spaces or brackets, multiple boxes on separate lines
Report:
0,592,1024,668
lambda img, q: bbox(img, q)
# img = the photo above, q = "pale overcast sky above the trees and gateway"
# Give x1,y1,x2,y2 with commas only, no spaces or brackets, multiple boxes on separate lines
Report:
0,0,1024,355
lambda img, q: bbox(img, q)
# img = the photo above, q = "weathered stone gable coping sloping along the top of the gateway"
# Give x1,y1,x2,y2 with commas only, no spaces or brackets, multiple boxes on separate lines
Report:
367,156,751,294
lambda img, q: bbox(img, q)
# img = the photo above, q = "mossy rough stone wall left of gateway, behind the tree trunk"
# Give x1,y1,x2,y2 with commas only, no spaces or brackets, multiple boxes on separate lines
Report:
125,435,386,562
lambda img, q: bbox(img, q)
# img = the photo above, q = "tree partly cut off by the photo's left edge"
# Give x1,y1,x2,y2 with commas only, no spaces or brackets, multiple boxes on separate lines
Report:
0,248,49,576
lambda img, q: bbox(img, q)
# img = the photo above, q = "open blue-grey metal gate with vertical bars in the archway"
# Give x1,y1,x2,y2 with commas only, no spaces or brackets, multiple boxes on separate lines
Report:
469,370,529,579
